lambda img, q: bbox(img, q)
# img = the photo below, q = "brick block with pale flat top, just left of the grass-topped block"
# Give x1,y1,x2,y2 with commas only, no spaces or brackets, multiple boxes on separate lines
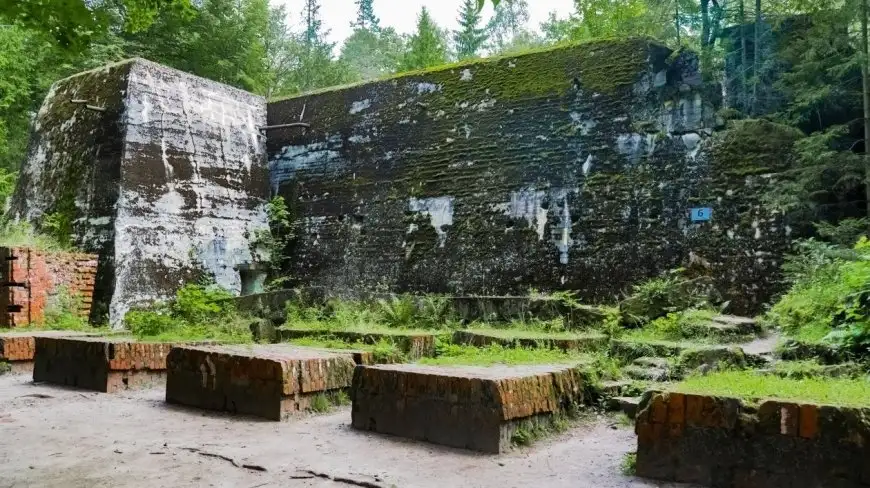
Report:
351,364,586,453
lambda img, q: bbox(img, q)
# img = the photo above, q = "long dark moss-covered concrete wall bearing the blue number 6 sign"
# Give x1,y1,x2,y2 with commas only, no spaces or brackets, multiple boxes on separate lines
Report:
267,39,790,310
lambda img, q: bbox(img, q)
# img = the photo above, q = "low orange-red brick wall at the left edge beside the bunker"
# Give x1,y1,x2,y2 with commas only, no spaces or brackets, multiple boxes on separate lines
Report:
0,247,97,327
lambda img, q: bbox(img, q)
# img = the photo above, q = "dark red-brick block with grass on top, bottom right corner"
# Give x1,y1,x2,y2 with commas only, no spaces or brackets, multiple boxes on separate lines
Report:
636,392,870,488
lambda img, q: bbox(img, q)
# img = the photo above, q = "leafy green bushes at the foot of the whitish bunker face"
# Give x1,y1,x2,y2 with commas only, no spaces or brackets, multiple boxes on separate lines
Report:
124,284,253,343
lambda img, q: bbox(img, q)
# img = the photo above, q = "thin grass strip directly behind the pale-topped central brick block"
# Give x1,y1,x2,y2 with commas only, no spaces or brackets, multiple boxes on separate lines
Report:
420,344,591,366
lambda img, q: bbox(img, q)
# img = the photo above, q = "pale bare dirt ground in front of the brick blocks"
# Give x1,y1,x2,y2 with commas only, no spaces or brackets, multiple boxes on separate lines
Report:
0,374,696,488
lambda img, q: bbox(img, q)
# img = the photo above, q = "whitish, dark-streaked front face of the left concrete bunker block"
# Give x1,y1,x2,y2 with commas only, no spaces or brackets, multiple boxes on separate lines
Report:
111,62,268,318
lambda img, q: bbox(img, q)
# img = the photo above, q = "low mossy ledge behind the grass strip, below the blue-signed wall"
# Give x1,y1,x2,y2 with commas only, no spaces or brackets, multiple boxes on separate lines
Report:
453,329,609,351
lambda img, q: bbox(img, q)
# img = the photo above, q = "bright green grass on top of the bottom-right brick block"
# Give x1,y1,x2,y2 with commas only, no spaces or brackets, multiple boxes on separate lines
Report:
674,371,870,407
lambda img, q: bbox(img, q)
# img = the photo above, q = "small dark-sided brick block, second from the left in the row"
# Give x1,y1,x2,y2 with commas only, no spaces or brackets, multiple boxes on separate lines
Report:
33,337,179,393
